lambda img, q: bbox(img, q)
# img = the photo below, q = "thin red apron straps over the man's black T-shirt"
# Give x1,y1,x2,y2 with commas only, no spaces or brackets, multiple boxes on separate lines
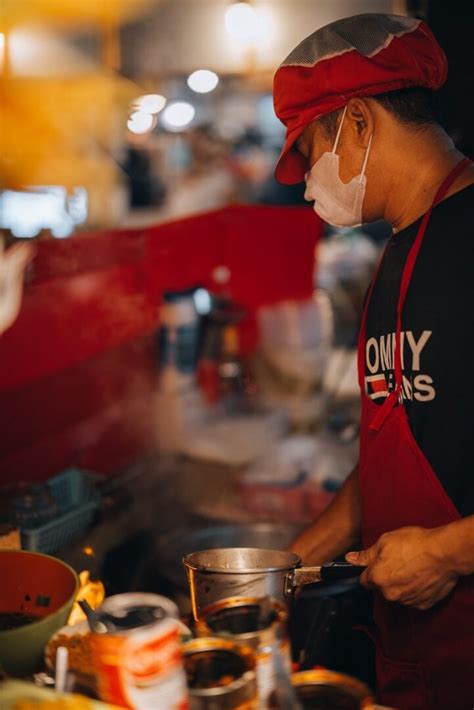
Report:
366,158,471,431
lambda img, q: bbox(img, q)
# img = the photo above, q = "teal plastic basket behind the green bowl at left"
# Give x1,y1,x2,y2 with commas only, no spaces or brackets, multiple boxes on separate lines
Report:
21,468,100,553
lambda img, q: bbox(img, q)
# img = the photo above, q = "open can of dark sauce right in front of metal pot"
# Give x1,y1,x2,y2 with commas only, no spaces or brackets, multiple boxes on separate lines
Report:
196,597,291,707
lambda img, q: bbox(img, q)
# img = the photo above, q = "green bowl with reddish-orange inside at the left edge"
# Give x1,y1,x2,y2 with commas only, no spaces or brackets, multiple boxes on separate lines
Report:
0,550,79,675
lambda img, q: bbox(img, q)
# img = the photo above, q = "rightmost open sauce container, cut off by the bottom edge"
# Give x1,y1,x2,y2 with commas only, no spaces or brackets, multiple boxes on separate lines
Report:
269,669,375,710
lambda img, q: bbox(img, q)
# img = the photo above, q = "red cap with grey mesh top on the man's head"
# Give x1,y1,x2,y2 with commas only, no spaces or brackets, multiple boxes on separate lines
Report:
273,13,448,185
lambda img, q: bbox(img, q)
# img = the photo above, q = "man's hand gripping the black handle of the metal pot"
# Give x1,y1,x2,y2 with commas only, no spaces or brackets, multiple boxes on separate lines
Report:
346,527,459,610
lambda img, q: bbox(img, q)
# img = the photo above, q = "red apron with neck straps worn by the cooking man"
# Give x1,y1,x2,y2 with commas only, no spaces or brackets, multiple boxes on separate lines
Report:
358,159,474,710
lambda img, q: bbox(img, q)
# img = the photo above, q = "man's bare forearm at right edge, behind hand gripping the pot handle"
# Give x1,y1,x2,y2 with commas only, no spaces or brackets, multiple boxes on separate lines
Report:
433,515,474,575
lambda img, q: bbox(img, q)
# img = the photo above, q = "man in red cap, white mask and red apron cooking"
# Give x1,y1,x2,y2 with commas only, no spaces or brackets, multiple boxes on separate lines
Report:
274,14,474,710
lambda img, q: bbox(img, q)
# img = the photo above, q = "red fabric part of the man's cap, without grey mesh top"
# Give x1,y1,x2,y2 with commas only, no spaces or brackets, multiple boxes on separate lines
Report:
273,17,447,184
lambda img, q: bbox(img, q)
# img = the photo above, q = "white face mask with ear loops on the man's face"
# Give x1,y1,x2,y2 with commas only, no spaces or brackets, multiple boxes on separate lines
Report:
304,106,372,227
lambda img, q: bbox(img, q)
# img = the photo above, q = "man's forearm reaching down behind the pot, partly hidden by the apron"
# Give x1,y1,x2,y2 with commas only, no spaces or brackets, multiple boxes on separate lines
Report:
290,466,360,564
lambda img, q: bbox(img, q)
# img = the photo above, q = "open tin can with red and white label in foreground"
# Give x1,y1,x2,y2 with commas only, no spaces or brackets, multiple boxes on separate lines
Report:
90,593,188,710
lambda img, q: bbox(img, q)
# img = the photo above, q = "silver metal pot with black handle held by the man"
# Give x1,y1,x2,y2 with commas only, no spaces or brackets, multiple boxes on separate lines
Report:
183,547,365,620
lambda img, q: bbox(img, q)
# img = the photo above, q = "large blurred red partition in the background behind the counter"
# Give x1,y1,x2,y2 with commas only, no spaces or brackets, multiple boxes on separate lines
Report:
0,205,322,485
